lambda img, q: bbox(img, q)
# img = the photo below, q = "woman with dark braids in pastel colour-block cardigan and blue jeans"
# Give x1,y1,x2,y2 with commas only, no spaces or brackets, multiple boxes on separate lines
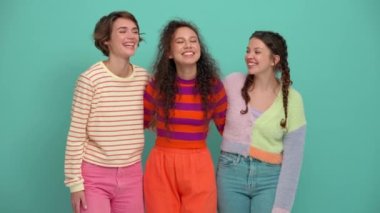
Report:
217,31,306,213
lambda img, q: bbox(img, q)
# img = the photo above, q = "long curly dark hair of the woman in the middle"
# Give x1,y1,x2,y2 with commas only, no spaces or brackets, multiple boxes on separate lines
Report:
153,20,220,126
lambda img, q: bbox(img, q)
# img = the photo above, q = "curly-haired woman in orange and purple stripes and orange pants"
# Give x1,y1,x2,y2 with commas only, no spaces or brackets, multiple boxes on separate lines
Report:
144,20,227,213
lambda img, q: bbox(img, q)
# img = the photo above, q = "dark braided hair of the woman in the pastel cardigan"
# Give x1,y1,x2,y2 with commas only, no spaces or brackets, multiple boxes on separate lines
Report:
240,31,292,128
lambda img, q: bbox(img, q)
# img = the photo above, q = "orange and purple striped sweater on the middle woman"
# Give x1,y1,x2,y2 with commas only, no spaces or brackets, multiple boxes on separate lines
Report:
144,77,227,149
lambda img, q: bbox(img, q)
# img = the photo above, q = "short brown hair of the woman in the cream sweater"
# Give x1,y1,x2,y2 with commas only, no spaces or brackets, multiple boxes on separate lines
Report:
93,11,143,56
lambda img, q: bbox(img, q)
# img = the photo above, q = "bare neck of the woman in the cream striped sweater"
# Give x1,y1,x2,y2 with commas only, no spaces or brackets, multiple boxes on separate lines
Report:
104,57,133,78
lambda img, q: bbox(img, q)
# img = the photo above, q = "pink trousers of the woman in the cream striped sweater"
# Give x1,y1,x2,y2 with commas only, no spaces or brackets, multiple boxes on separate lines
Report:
81,162,144,213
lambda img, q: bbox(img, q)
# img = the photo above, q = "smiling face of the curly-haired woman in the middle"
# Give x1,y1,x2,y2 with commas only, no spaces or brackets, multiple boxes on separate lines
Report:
169,27,201,66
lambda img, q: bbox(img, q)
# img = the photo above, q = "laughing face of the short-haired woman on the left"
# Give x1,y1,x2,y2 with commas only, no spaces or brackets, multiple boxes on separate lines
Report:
105,18,139,58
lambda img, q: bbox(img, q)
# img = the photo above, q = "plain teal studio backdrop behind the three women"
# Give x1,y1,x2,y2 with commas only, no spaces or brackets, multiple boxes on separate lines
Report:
0,0,380,213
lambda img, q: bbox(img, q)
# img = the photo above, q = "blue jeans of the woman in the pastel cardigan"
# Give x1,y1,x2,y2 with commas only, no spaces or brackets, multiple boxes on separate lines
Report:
217,151,281,213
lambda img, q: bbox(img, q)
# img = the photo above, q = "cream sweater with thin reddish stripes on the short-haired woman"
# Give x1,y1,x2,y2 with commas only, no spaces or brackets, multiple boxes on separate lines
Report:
65,62,149,192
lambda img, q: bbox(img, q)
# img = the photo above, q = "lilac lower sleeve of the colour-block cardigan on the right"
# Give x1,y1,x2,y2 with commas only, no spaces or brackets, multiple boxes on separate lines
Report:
272,125,306,213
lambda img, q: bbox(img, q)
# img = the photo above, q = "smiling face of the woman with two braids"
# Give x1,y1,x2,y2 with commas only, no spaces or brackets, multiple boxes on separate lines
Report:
245,37,279,75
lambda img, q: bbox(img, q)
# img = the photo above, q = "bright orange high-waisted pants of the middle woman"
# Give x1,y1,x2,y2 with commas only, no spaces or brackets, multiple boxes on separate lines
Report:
144,146,217,213
